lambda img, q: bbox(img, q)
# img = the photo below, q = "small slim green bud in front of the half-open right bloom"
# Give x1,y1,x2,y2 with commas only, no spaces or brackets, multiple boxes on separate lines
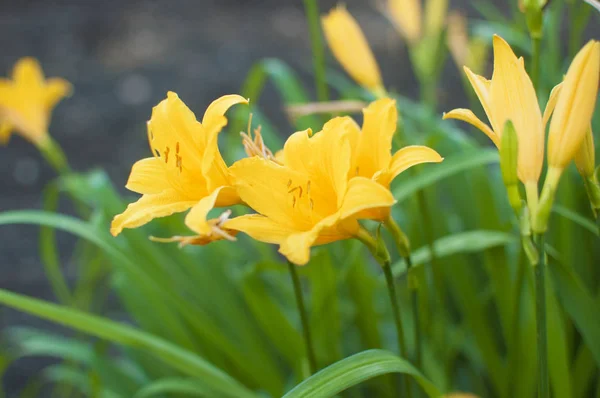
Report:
500,120,521,216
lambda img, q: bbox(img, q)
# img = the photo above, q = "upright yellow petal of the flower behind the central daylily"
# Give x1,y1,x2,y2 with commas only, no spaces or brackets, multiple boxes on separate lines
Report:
352,98,398,178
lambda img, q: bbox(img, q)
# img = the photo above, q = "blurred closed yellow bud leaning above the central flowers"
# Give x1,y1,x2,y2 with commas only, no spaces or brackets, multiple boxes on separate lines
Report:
321,5,385,95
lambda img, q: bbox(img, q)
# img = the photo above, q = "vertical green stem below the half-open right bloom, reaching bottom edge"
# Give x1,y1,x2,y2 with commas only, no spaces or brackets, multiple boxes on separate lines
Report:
535,234,550,398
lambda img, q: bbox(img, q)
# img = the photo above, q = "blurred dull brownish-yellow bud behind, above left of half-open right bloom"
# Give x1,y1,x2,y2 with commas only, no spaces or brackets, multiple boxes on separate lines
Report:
446,11,489,75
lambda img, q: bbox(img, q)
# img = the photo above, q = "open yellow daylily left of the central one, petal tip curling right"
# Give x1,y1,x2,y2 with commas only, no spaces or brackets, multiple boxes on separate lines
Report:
111,92,248,236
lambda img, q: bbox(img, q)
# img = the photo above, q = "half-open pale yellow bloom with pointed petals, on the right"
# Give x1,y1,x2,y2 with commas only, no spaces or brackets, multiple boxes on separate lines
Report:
444,36,553,185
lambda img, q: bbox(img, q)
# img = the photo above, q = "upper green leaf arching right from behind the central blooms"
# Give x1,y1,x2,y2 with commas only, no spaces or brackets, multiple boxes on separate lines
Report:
392,149,500,202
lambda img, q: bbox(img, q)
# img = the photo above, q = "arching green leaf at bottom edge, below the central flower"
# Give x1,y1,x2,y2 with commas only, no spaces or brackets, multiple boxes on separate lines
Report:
284,350,442,398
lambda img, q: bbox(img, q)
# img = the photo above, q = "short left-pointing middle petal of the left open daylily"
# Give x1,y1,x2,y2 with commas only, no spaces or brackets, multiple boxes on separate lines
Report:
125,158,172,194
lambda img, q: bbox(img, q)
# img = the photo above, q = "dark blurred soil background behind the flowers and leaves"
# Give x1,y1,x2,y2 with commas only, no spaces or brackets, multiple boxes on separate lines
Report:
0,0,596,396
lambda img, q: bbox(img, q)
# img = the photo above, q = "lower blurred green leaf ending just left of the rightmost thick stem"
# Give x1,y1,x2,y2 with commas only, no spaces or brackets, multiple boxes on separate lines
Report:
392,230,516,277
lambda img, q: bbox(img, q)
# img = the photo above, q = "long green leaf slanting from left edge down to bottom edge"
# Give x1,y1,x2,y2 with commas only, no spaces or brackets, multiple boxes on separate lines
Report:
0,289,255,398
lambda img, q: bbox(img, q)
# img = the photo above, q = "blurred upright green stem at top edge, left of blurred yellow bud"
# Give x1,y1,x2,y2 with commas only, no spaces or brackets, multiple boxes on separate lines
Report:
304,0,329,101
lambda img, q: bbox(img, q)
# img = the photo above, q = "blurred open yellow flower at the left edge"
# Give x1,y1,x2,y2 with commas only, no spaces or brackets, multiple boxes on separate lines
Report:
0,57,72,146
